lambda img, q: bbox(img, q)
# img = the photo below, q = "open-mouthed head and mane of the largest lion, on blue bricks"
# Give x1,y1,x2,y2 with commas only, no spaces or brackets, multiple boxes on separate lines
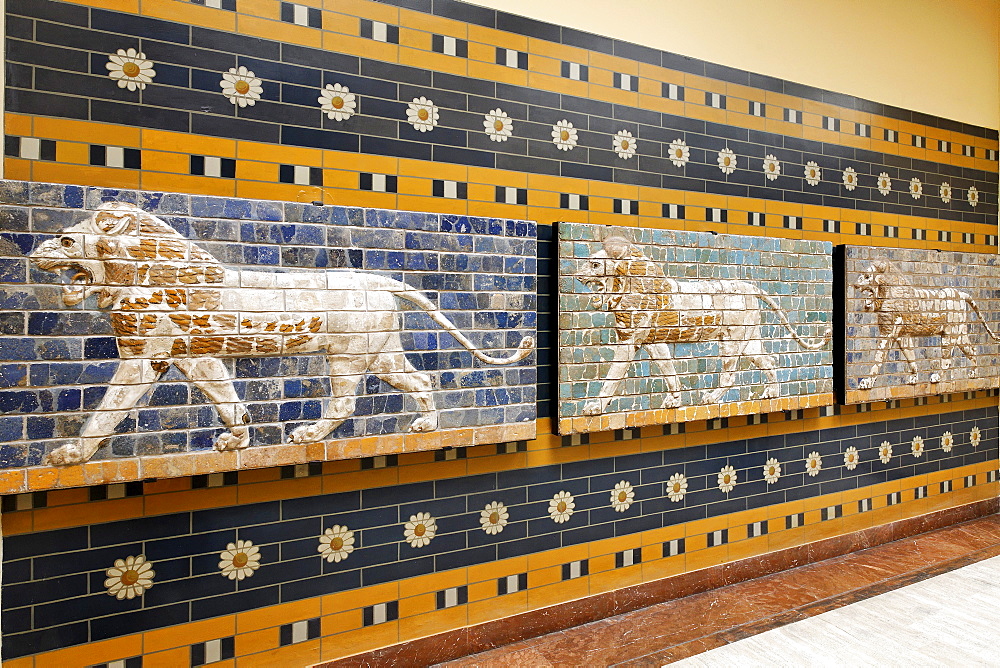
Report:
29,202,223,308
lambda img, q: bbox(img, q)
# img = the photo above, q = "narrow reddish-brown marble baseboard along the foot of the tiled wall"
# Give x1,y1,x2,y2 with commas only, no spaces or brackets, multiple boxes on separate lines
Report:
317,498,1000,668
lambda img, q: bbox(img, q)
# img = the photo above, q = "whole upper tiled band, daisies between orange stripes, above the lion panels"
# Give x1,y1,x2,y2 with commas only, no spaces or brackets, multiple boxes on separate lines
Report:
6,0,997,250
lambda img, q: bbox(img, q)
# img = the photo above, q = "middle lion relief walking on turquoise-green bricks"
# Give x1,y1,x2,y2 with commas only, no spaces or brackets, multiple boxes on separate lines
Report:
574,236,832,415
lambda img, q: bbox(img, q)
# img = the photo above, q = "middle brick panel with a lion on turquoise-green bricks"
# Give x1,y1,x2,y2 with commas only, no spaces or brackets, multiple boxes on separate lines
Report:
559,223,833,434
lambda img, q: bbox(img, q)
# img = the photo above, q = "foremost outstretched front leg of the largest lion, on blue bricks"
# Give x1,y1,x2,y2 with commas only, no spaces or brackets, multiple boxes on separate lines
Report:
45,359,163,466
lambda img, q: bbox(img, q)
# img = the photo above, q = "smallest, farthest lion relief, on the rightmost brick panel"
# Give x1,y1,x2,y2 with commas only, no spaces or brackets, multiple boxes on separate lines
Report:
852,260,1000,390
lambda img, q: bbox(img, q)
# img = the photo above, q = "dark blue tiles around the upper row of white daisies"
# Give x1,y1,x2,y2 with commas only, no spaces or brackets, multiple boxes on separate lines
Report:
3,6,996,222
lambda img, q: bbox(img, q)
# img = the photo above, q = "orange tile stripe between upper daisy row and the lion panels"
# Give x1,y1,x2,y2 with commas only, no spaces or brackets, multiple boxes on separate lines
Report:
5,114,996,253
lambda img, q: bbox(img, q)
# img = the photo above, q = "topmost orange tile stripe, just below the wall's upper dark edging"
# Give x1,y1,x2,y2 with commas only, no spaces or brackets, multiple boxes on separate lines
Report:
43,0,998,172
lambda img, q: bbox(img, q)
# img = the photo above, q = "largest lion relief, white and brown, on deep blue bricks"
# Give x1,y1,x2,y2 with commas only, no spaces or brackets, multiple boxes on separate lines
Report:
30,203,535,465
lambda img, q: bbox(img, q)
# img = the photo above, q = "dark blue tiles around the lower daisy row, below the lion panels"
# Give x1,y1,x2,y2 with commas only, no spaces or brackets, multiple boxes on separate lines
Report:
3,408,1000,655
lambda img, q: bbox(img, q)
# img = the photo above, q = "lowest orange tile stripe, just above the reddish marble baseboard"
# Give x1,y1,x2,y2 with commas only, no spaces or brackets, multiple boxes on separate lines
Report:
19,462,1000,668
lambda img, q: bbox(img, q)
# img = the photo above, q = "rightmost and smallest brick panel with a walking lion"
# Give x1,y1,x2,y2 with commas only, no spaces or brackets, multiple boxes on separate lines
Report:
842,246,1000,403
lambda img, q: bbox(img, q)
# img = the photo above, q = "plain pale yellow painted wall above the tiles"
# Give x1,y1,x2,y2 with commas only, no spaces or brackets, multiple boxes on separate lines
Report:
462,0,1000,128
